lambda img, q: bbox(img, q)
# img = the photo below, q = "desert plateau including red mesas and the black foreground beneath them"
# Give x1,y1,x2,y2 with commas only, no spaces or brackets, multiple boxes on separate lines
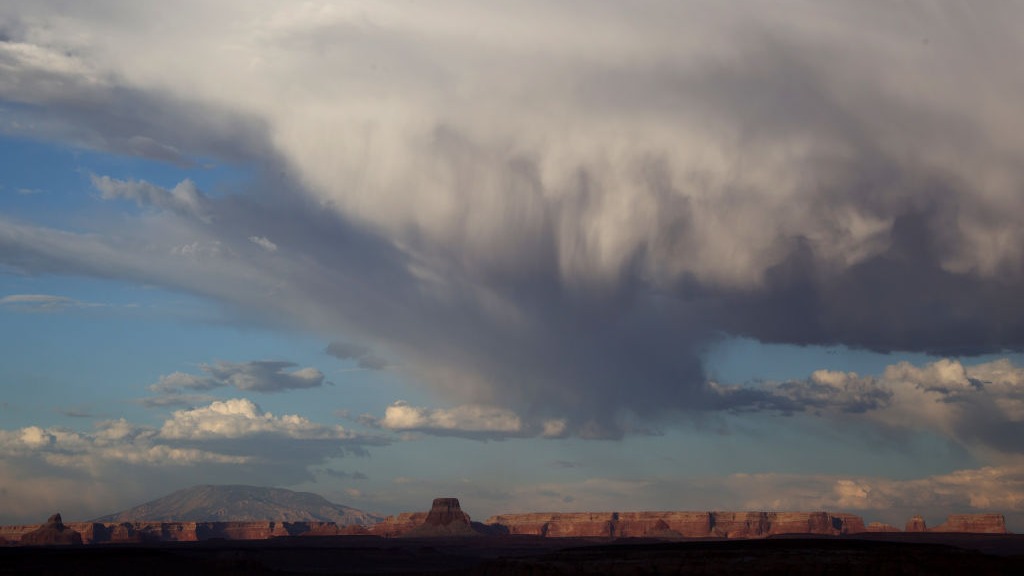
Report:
0,497,1024,575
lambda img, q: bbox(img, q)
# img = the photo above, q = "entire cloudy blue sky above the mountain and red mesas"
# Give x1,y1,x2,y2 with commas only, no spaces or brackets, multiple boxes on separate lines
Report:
0,0,1024,531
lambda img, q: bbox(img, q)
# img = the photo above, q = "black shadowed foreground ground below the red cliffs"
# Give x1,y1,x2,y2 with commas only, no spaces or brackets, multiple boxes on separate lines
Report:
6,534,1024,576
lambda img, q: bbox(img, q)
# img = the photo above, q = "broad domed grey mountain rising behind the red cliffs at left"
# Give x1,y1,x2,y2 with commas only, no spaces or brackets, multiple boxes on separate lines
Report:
93,485,383,526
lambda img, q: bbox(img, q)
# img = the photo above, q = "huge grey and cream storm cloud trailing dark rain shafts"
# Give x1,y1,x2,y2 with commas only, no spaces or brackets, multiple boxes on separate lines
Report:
0,1,1024,438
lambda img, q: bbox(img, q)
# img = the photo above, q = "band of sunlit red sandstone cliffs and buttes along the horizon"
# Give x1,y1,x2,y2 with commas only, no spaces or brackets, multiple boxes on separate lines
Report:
0,506,1008,546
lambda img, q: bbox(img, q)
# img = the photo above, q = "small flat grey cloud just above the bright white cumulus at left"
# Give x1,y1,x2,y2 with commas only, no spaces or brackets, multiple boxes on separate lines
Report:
150,360,326,393
